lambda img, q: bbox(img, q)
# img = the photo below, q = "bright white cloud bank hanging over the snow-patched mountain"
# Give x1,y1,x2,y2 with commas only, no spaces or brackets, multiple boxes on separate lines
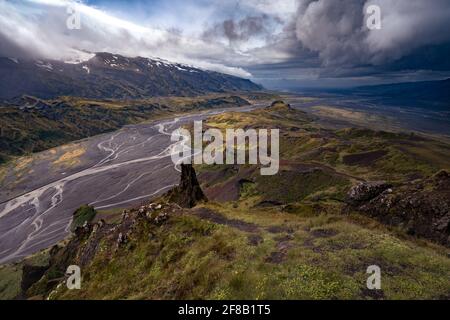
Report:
0,0,255,77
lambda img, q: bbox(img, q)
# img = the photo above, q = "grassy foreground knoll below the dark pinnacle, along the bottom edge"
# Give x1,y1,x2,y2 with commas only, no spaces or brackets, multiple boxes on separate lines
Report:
52,203,450,299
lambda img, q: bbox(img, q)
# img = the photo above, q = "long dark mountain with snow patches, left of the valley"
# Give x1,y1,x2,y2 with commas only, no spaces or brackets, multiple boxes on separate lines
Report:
0,53,262,100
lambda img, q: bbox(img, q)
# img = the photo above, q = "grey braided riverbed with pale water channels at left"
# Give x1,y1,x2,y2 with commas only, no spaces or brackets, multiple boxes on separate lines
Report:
0,100,264,263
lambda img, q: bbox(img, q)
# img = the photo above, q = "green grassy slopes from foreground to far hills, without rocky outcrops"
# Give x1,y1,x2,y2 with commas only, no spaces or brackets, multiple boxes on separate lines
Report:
43,101,450,299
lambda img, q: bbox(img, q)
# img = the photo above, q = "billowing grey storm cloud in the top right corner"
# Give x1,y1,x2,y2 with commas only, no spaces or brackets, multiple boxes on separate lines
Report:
296,0,450,66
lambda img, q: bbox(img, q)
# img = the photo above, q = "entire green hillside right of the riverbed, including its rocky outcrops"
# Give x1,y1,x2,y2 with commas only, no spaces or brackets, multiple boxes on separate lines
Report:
5,102,450,299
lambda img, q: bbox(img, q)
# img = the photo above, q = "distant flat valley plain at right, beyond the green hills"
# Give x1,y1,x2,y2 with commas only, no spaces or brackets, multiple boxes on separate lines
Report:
283,93,450,139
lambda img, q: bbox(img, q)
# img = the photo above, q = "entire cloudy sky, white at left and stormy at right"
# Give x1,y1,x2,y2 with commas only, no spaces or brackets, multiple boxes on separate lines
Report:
0,0,450,90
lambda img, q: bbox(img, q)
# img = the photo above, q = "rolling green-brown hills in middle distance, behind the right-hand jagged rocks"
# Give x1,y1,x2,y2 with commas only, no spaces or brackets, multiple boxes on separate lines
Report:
206,104,450,183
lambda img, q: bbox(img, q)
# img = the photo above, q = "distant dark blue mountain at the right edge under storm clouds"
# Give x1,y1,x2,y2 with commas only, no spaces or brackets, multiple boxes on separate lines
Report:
352,79,450,110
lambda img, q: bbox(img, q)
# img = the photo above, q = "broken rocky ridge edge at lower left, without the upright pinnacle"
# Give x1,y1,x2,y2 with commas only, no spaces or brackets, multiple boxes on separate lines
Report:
20,202,182,298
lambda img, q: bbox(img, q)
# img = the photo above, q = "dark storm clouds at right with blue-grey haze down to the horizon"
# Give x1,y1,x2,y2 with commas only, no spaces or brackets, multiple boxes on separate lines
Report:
248,0,450,87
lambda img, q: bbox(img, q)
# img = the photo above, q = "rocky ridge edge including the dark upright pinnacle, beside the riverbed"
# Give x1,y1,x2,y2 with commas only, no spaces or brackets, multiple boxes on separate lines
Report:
21,165,207,298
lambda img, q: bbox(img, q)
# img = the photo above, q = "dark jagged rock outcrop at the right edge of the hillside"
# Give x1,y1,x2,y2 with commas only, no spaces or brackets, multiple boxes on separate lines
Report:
348,171,450,246
